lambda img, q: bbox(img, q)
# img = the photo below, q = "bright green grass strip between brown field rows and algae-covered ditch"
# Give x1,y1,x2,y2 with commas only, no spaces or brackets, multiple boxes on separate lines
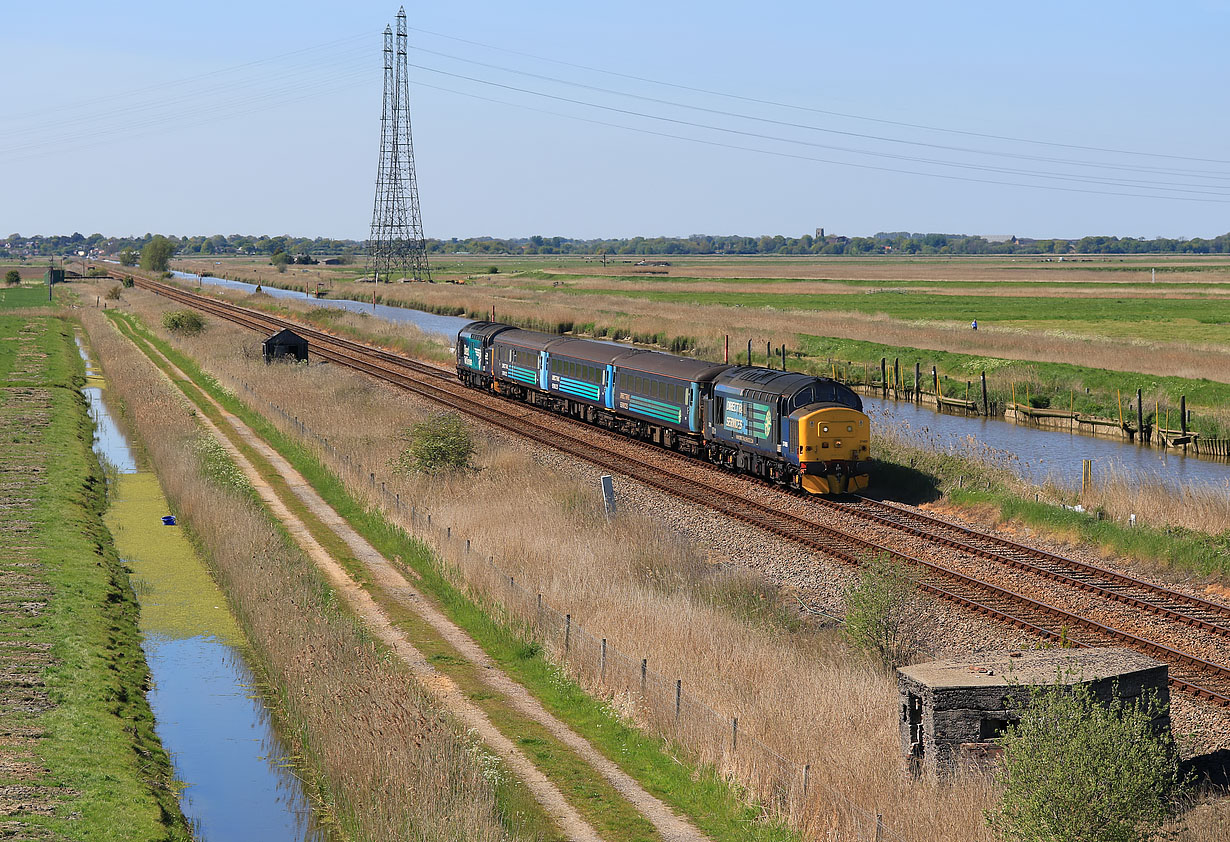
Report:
0,316,188,842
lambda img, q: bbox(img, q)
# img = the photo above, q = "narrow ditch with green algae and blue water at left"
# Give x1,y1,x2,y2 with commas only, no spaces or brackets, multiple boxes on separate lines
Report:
77,337,331,842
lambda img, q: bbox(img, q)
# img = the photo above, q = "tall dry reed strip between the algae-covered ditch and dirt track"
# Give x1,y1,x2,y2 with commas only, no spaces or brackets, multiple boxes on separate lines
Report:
75,304,519,842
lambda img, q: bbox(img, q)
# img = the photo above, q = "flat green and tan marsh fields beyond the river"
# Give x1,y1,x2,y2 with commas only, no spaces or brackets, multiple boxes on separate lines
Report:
168,250,1230,438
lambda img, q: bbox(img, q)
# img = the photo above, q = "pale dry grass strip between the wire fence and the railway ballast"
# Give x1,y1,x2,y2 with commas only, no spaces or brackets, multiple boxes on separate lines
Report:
110,283,991,842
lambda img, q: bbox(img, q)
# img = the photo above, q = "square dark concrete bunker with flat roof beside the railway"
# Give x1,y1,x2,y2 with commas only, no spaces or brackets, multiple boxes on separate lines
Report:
897,649,1170,774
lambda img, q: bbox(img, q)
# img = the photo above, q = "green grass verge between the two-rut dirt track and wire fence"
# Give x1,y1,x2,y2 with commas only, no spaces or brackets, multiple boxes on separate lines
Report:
108,308,797,842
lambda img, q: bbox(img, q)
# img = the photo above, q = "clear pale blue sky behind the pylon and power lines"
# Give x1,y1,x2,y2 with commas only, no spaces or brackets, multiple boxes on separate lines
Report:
0,0,1230,240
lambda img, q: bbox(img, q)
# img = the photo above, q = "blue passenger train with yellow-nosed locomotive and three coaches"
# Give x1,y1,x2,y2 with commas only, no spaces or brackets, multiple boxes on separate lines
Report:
456,321,871,494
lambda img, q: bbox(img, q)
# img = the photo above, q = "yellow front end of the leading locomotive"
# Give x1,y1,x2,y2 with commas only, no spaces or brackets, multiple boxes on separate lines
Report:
795,407,871,494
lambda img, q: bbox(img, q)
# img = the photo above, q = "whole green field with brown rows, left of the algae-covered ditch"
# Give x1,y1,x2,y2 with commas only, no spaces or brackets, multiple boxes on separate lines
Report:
0,310,189,842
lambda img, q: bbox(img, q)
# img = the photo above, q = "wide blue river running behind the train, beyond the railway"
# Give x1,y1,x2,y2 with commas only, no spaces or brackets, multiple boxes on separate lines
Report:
173,272,1230,493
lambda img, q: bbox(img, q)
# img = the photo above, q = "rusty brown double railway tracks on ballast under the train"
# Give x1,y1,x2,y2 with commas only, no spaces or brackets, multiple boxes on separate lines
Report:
135,277,1230,707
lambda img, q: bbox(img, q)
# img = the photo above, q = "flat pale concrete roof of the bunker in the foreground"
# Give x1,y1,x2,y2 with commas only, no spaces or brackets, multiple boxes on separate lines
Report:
898,649,1162,688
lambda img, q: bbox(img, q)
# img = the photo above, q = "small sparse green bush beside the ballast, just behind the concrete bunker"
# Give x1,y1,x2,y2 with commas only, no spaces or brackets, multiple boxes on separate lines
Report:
845,556,934,670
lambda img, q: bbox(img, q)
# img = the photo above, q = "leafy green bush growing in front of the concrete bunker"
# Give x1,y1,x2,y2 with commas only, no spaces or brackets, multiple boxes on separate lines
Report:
988,681,1182,842
